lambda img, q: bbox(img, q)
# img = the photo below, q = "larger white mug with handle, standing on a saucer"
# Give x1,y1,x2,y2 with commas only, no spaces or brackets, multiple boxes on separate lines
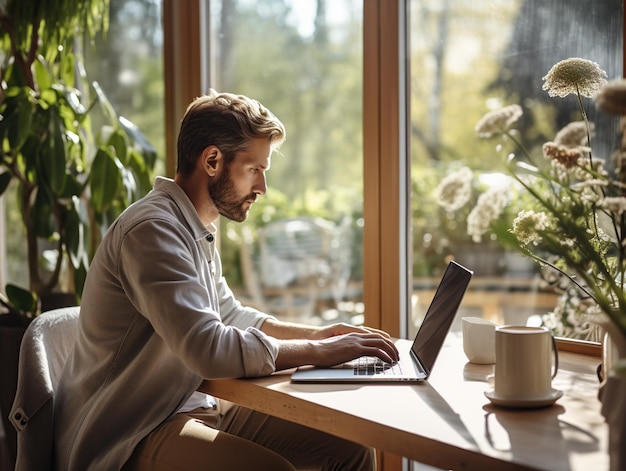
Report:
494,326,559,400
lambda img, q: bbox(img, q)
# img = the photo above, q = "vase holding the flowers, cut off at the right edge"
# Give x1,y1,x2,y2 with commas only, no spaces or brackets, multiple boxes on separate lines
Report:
598,326,626,471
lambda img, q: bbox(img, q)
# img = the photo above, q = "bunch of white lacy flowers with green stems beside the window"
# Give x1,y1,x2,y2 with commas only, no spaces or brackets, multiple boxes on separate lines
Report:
439,58,626,346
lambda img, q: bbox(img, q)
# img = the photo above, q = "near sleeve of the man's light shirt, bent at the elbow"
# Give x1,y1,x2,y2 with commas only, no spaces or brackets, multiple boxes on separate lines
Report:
118,218,278,378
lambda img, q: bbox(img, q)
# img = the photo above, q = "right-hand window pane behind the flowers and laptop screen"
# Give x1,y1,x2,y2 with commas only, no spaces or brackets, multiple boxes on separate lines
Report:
409,0,623,340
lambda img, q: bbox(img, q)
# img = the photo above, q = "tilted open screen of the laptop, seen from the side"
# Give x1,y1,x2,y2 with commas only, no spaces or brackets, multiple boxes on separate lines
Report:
411,261,473,373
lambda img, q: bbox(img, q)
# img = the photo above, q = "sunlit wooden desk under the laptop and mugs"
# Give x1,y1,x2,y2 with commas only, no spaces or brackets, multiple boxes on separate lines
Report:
201,334,608,471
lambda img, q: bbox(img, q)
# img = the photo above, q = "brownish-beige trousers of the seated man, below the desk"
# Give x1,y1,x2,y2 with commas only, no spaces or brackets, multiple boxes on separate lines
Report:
123,406,376,471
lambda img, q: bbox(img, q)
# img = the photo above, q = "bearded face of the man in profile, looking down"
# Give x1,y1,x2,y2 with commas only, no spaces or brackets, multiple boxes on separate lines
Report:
208,139,271,222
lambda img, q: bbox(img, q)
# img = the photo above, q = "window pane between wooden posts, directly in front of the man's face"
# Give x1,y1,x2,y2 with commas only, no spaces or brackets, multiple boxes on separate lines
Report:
206,0,363,323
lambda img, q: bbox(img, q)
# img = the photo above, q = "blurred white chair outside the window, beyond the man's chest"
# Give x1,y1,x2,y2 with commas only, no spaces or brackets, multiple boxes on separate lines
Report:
238,217,353,319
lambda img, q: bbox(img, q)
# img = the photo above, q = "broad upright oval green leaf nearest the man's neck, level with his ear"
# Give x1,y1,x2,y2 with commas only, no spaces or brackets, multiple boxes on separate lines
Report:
90,148,121,213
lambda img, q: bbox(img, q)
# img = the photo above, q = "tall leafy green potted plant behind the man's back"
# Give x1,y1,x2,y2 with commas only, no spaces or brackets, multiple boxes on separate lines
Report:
0,0,156,462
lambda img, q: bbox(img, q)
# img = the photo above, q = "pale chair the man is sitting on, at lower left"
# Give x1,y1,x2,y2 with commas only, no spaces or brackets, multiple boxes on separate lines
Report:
9,306,80,471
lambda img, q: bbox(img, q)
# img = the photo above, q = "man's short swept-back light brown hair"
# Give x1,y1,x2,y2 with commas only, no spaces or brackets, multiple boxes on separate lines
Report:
176,89,286,176
